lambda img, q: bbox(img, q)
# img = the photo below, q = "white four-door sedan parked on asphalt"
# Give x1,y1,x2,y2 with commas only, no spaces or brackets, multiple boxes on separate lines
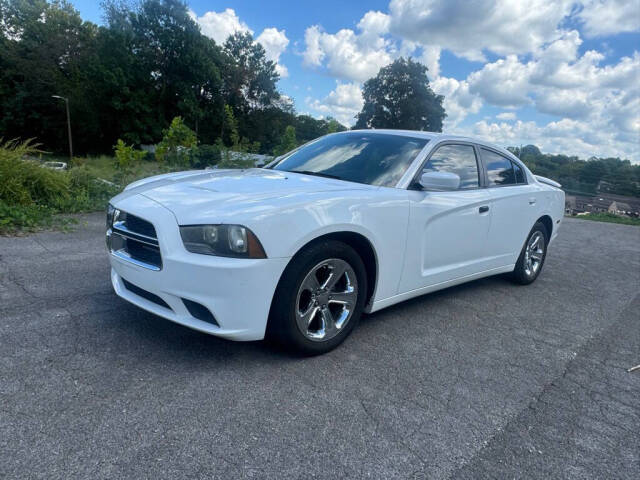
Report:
107,130,564,354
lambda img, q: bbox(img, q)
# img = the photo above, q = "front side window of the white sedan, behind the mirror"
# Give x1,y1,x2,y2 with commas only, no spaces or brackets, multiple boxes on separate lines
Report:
423,145,479,190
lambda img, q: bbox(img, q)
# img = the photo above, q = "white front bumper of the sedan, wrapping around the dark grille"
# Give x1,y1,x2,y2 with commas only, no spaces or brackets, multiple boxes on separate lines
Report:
109,195,289,340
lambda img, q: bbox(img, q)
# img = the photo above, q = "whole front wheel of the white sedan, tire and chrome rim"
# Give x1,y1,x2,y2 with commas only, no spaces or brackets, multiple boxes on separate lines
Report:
267,240,367,355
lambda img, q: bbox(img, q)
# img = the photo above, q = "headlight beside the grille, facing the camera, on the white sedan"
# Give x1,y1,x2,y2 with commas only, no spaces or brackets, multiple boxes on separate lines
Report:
180,225,267,258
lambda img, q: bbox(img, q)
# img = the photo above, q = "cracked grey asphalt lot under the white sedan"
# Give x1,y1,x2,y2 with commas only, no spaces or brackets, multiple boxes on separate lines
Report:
0,215,640,479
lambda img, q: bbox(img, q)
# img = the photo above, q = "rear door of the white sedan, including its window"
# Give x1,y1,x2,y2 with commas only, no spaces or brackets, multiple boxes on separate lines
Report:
479,146,538,268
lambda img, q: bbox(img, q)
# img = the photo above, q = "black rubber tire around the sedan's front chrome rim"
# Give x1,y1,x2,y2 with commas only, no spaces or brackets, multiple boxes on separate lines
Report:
267,240,367,355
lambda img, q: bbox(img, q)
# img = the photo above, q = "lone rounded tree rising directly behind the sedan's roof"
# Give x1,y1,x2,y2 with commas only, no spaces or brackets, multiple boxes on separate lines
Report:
356,58,446,132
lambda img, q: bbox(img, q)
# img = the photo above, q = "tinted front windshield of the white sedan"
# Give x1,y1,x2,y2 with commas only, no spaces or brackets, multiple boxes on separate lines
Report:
273,132,429,187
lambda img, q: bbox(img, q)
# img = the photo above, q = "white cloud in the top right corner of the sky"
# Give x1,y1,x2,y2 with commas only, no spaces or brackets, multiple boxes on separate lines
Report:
577,0,640,37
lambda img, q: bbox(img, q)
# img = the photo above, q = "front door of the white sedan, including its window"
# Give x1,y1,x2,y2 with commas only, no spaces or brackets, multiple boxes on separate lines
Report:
399,142,491,293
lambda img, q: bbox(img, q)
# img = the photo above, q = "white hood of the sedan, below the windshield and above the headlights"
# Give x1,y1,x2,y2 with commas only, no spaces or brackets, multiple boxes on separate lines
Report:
118,168,376,224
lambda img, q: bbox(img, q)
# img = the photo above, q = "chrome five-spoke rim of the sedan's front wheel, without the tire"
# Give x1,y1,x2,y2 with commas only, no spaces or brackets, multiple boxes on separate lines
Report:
296,258,358,341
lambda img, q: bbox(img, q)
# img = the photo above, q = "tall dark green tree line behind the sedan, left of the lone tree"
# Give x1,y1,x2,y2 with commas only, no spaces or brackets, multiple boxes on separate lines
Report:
0,0,345,155
